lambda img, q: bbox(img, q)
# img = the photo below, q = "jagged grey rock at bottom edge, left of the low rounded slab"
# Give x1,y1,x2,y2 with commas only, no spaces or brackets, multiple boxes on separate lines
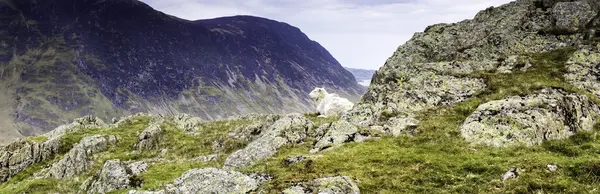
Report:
80,160,148,194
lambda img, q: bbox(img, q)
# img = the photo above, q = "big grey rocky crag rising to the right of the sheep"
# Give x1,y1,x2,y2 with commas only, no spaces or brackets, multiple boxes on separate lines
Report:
345,0,600,125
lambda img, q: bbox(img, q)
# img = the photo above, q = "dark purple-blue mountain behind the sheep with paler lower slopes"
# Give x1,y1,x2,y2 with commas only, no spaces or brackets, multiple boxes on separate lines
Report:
0,0,363,142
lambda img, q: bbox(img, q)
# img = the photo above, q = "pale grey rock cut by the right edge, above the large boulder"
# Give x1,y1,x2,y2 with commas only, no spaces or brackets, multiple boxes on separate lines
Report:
565,48,600,97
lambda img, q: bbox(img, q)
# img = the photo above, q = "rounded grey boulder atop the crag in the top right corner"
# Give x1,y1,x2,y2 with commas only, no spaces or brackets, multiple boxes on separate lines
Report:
552,1,597,32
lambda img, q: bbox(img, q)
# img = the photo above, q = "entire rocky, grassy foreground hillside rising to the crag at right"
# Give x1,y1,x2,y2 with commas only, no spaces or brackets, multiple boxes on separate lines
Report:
0,0,600,193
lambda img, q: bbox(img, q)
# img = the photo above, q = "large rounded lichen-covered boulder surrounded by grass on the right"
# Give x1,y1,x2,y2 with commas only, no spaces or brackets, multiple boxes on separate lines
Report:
460,89,600,147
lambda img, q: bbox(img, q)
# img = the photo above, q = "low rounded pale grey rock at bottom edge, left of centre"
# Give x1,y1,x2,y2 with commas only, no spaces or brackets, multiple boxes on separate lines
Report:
129,168,266,194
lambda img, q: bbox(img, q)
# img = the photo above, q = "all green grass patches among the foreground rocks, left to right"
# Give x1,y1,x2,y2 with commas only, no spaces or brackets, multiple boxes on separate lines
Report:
0,49,600,193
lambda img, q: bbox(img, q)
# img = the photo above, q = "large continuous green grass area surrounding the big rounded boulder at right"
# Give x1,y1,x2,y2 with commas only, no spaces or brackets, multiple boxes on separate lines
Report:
245,48,600,193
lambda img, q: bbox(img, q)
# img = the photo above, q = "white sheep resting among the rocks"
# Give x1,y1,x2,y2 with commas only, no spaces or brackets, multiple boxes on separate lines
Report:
308,88,354,117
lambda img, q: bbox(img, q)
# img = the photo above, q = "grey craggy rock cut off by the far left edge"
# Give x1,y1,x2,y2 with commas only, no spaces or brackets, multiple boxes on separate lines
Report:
0,138,60,183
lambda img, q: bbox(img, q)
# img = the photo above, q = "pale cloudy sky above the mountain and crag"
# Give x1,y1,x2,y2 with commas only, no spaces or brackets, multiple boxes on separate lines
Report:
141,0,510,70
